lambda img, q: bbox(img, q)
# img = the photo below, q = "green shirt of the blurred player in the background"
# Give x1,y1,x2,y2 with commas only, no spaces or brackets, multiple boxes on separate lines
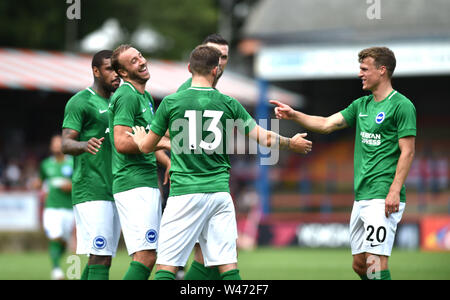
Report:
40,155,73,208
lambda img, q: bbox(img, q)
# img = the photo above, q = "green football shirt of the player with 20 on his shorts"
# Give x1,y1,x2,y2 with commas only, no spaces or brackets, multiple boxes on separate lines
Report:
341,90,416,202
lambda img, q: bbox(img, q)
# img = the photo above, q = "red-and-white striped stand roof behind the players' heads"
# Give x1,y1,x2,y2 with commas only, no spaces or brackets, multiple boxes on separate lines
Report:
0,48,303,107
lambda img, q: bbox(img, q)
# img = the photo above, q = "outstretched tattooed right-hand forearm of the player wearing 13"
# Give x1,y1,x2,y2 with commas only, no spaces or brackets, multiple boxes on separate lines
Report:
248,125,312,154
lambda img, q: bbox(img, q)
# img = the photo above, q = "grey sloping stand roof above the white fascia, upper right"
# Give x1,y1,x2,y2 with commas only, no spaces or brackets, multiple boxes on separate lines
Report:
243,0,450,43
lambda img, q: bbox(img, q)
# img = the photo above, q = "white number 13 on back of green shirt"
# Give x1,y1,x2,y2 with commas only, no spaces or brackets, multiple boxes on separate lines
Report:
184,110,223,150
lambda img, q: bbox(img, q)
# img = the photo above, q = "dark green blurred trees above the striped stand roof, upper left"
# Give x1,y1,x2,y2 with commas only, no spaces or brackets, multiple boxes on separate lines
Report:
0,0,218,59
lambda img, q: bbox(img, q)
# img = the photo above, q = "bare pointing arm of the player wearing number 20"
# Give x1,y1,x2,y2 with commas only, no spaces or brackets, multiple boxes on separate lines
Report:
269,100,348,134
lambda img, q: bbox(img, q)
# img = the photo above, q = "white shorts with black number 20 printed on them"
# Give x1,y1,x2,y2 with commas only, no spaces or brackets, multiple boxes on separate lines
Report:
350,199,405,256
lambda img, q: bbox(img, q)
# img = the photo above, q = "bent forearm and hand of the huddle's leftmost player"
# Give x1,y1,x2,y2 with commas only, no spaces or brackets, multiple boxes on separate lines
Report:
61,128,105,155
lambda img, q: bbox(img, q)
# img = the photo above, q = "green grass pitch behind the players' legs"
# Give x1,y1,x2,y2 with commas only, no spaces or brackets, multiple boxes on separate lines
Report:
0,247,450,280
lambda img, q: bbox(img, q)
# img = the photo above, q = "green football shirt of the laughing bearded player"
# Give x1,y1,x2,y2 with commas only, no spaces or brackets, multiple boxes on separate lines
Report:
109,82,158,194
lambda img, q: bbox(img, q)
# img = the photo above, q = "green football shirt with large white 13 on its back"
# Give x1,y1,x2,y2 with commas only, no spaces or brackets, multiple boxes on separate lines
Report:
150,87,256,196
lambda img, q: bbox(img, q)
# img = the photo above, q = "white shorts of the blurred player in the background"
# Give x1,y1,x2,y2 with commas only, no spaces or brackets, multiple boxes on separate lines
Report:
42,208,75,242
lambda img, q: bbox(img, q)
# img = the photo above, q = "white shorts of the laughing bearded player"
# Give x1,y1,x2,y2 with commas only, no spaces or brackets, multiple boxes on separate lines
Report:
114,187,162,255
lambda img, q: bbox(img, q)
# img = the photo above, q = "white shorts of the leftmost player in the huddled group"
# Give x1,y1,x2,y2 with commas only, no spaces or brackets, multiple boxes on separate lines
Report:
74,200,120,256
